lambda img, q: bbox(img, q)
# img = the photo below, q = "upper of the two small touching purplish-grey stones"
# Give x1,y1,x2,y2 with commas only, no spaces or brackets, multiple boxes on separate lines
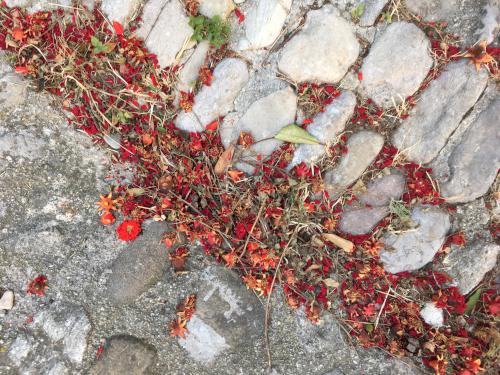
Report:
358,170,406,207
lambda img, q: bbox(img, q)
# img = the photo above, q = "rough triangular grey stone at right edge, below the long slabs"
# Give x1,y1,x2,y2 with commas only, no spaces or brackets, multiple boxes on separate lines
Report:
443,242,500,295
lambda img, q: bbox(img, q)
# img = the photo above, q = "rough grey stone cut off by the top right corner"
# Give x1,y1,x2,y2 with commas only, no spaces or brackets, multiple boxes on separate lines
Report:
405,0,500,45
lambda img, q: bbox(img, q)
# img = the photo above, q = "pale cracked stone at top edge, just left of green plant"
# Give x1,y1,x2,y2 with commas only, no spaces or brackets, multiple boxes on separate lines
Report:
137,0,193,67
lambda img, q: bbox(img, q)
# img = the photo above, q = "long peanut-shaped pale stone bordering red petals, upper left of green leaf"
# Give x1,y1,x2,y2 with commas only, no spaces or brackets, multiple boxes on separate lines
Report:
175,58,249,132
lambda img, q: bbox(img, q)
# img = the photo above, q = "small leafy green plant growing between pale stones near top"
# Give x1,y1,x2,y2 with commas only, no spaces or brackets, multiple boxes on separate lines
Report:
189,15,231,48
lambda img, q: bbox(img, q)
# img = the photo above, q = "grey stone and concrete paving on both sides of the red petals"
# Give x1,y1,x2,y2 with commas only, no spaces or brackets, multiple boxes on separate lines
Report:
0,0,500,375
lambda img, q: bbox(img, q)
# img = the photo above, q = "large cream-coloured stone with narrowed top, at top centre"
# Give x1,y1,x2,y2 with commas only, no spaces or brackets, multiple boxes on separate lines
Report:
278,5,359,83
